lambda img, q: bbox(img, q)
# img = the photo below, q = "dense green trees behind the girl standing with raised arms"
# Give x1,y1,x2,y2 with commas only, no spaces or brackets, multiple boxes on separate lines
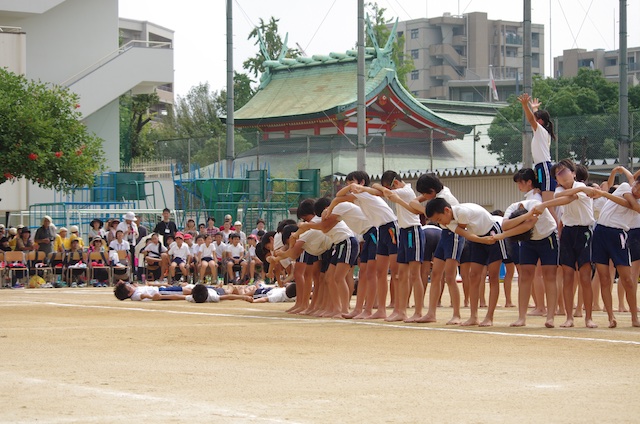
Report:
487,68,640,164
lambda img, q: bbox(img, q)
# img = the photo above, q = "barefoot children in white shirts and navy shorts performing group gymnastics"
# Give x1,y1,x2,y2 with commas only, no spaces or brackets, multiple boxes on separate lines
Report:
116,94,640,328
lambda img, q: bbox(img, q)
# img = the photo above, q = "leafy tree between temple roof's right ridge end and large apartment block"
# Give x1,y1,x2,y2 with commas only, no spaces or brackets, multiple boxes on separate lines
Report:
365,3,415,89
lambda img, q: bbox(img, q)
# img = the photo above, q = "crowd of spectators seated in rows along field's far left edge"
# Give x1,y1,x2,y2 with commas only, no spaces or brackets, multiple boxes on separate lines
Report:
0,209,265,288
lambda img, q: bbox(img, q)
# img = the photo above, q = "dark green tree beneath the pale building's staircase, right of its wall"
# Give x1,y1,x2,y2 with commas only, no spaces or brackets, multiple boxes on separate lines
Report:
120,92,160,163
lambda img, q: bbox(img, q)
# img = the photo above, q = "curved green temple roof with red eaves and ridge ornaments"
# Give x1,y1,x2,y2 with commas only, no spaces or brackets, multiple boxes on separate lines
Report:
234,48,472,140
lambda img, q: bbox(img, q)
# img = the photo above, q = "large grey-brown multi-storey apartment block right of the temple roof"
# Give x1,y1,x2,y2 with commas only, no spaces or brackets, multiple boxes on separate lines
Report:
397,12,544,102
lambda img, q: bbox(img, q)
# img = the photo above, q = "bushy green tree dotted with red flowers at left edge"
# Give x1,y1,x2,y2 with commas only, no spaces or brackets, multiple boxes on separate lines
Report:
0,69,104,191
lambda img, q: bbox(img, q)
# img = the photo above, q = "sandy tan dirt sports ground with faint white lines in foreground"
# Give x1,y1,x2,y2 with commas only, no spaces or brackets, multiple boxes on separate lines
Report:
0,288,640,423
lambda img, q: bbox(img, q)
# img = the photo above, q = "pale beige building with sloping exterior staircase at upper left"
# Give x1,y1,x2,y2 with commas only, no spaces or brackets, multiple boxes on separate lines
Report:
0,0,173,210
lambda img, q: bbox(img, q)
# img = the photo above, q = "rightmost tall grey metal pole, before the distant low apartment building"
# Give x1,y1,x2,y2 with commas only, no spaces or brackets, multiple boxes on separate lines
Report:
618,0,629,168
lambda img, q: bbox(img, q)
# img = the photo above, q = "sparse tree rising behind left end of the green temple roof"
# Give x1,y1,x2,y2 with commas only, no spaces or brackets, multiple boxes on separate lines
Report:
242,16,300,81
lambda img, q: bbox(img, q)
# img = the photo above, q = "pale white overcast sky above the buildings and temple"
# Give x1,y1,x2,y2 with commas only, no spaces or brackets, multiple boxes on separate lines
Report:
119,0,640,95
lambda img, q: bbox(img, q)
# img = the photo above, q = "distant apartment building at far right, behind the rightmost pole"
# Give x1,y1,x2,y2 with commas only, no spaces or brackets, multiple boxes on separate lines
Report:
553,47,640,85
